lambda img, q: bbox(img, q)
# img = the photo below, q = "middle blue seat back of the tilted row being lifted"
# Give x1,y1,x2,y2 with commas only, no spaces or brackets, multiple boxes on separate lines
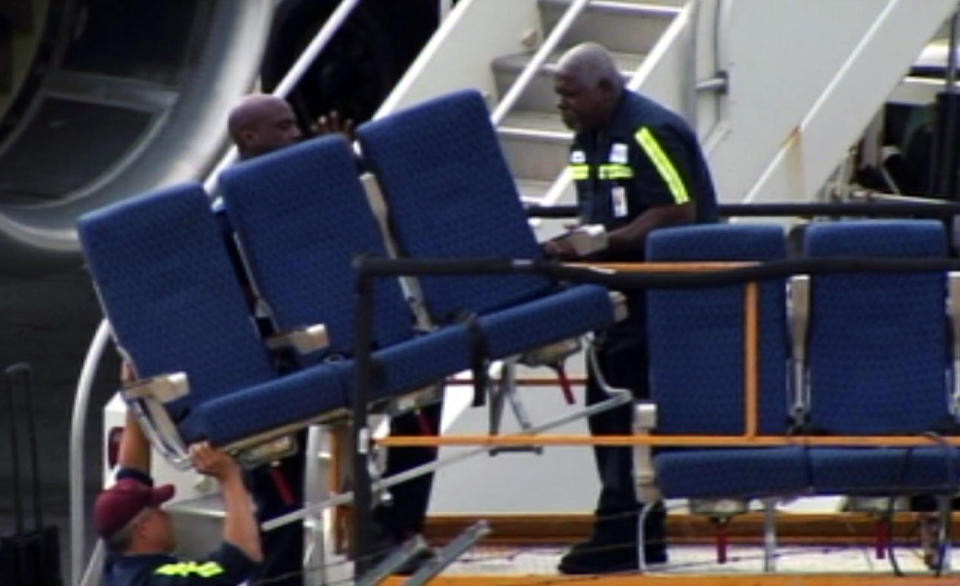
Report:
220,135,413,354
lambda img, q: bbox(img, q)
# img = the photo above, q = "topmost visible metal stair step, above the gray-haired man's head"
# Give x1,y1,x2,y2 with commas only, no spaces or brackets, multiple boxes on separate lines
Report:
539,0,681,53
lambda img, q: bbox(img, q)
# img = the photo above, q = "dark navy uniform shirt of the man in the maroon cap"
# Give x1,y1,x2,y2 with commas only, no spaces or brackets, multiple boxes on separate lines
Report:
103,468,257,586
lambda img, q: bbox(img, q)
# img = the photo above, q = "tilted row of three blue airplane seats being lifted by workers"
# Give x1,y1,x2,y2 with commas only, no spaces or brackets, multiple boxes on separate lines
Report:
73,91,616,460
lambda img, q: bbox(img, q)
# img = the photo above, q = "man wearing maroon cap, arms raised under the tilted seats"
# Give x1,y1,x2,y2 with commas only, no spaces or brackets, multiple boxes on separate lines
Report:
94,374,263,586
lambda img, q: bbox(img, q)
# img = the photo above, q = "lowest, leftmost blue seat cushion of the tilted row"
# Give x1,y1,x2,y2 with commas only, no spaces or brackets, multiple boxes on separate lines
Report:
178,361,353,446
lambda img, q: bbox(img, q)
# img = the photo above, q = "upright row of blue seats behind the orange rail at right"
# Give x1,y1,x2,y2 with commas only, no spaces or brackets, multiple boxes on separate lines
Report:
647,220,960,506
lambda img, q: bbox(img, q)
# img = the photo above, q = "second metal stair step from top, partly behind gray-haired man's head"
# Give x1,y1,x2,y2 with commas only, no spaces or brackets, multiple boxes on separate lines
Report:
492,47,645,112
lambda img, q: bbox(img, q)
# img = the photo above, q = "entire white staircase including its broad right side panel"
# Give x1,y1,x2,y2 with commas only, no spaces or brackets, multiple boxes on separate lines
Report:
377,0,957,208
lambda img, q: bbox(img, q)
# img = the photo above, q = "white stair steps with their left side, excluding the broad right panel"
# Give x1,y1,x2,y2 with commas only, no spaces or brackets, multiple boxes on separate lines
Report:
377,0,685,217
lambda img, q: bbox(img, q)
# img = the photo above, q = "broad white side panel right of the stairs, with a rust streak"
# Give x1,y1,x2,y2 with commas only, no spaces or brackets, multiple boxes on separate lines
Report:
710,0,956,202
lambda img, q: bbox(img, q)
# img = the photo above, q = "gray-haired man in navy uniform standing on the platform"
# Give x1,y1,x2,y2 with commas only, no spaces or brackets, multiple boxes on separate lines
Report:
543,43,717,574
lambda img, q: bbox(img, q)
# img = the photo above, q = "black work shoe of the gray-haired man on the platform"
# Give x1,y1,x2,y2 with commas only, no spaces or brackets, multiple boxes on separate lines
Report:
557,535,667,574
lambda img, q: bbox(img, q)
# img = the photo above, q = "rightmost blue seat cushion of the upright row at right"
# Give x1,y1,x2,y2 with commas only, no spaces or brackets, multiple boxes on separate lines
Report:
810,446,960,495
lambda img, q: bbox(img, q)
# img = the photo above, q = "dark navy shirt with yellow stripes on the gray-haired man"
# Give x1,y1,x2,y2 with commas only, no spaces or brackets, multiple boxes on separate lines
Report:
569,90,717,261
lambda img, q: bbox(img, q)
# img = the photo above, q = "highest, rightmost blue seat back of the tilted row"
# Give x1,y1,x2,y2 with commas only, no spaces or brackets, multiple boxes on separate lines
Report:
357,90,552,321
